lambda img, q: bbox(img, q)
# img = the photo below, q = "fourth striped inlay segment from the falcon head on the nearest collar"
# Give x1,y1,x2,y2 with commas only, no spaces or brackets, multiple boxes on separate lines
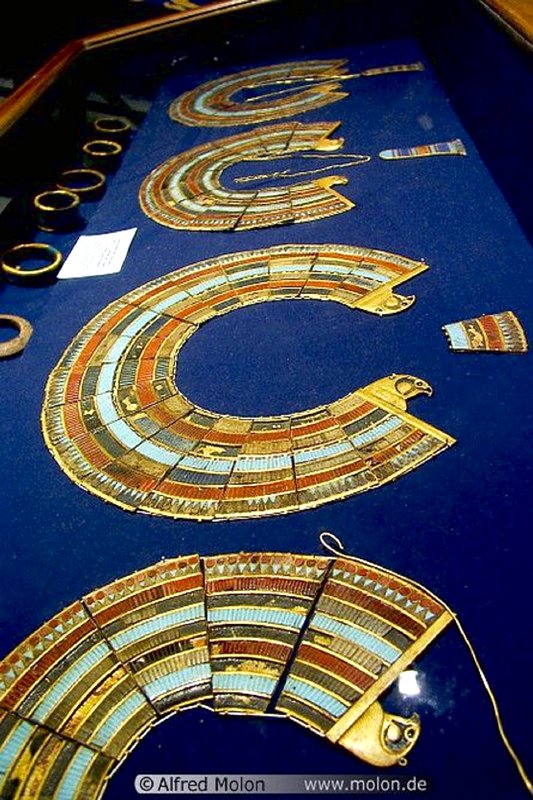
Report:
0,603,155,757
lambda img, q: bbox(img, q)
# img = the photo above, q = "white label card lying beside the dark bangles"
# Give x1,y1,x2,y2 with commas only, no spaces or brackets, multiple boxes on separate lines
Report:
57,228,137,278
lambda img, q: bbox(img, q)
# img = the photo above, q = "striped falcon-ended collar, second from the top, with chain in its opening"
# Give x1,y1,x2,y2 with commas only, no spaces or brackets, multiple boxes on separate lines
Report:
139,122,353,231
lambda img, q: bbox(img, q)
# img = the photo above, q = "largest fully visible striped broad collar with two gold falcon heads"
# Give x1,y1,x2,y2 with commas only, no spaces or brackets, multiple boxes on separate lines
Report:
42,245,453,520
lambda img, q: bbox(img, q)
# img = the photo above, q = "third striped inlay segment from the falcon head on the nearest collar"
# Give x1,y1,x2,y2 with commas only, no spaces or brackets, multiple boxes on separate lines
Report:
84,556,211,711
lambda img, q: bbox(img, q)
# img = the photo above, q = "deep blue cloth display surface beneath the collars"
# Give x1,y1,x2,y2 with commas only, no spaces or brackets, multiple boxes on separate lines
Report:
0,28,533,800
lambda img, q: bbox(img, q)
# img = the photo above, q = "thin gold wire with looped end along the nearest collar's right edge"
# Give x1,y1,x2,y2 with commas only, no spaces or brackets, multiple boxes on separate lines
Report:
319,531,533,795
